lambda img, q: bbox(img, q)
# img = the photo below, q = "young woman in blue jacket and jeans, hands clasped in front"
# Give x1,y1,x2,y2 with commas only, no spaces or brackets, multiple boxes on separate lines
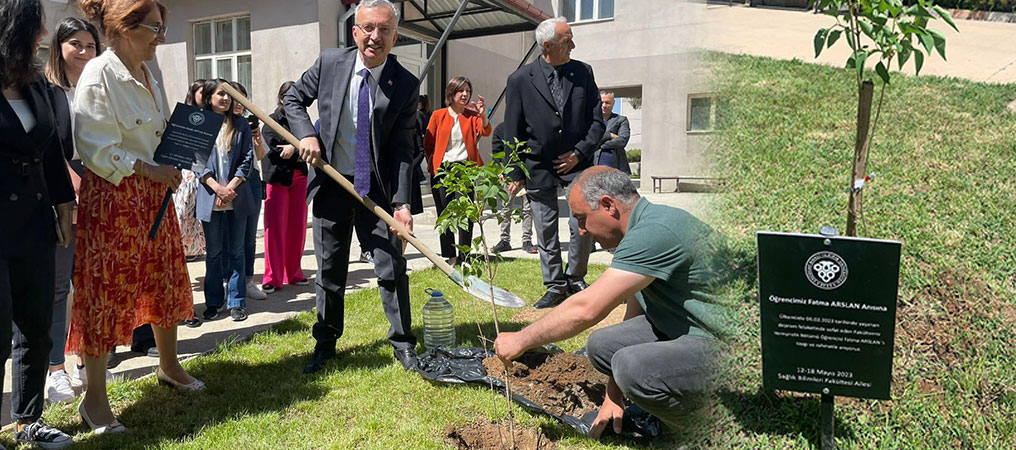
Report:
197,79,257,322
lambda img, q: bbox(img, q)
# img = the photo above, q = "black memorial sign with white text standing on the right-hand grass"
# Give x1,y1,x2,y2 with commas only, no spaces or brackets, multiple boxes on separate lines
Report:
756,232,900,399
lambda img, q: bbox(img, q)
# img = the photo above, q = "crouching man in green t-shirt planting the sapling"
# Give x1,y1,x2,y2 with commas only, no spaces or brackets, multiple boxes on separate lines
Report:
494,167,720,438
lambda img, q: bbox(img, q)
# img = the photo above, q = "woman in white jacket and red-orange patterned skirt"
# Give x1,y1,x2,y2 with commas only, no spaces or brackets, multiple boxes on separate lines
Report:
67,0,204,434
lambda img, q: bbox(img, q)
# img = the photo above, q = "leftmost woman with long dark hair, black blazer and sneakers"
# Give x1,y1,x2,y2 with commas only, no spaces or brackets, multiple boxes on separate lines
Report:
0,0,74,448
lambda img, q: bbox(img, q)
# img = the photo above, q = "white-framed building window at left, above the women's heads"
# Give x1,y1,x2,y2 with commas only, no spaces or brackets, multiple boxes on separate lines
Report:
194,15,252,95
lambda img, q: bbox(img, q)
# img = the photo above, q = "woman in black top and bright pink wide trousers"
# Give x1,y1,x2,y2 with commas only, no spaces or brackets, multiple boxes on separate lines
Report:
261,81,308,294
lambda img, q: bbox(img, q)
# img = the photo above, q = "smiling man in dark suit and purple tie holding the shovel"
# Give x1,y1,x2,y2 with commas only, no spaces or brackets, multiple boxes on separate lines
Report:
283,0,419,373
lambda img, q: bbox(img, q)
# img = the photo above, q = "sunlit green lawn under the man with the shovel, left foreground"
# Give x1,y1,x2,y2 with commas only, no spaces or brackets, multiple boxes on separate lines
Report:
11,260,675,449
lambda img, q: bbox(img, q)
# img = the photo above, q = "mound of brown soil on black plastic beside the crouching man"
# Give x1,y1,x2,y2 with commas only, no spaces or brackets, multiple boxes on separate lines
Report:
484,353,608,417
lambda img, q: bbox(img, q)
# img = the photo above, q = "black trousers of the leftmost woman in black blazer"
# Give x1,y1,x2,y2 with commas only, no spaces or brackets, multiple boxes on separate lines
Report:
0,239,56,422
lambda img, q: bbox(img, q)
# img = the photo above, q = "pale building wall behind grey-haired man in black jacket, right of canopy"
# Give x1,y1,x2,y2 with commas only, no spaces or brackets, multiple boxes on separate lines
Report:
440,0,710,188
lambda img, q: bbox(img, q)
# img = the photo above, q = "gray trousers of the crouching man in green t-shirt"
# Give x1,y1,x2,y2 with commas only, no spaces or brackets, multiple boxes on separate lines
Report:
586,315,719,426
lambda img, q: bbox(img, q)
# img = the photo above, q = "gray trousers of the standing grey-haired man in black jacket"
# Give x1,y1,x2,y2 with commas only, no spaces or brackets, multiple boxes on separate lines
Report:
526,181,592,294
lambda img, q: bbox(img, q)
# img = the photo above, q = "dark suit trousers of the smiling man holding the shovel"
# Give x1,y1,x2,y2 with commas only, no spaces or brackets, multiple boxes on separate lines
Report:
312,177,417,349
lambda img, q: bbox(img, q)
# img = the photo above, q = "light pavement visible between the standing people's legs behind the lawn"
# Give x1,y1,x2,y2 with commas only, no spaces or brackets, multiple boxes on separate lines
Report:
0,188,715,426
